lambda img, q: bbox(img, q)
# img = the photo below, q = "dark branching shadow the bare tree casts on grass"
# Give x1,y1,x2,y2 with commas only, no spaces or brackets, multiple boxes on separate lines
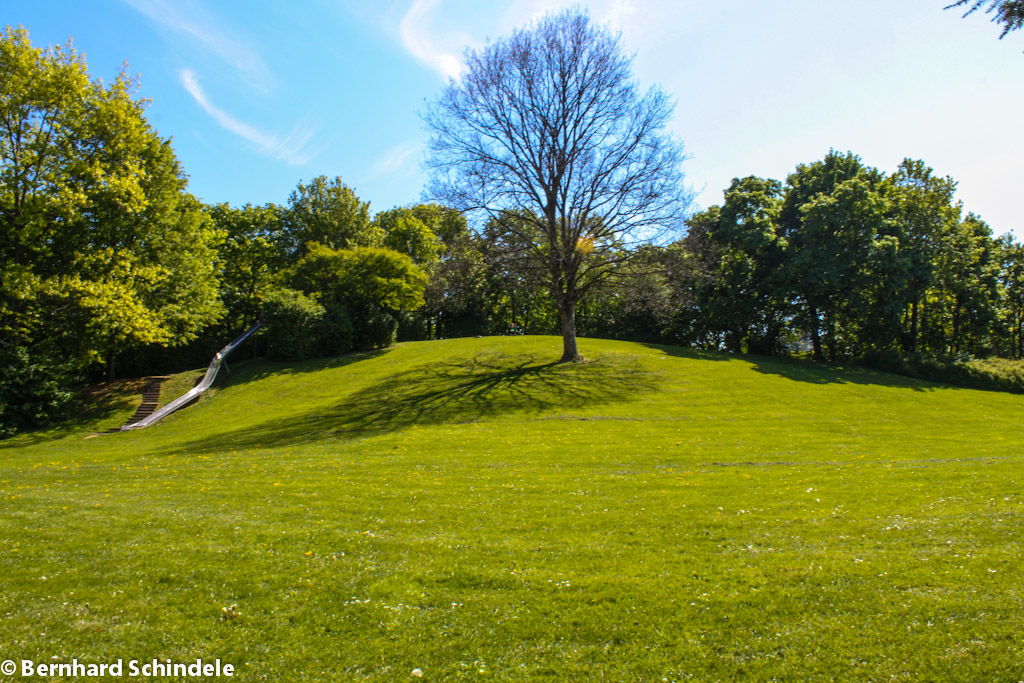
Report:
161,354,656,453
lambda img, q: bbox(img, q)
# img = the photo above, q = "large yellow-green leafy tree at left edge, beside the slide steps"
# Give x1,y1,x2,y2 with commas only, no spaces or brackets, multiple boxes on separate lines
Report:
0,28,220,387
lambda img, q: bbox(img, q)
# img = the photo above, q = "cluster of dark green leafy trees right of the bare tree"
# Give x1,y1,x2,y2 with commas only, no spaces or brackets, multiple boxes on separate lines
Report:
665,151,1024,368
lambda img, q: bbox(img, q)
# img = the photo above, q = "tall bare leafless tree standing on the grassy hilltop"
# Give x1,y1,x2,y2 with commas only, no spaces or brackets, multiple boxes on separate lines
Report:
424,10,689,361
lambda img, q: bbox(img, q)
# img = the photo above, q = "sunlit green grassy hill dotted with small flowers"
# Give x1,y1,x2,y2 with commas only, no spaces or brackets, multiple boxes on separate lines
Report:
0,337,1024,681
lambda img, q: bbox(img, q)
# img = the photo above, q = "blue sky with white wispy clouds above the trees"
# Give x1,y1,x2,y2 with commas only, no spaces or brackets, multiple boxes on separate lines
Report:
6,0,1024,236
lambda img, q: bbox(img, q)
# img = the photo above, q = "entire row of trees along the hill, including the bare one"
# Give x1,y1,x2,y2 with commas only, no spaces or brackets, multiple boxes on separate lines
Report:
0,20,1024,434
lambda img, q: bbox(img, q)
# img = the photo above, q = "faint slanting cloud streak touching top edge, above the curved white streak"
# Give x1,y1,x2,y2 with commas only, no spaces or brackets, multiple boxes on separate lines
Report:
124,0,274,92
